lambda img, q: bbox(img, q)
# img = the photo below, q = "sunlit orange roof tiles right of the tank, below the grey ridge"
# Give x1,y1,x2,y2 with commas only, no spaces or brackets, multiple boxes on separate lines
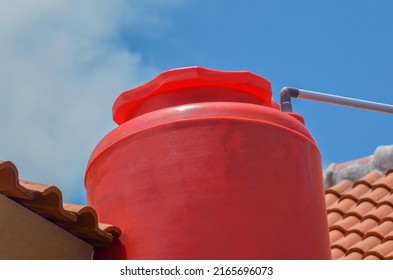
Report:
325,169,393,260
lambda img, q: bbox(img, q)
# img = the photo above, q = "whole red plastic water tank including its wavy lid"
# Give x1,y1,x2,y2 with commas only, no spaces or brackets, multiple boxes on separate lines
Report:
85,67,331,259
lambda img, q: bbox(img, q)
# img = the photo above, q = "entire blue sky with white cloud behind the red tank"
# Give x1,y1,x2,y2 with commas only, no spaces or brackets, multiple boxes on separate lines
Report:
0,0,393,203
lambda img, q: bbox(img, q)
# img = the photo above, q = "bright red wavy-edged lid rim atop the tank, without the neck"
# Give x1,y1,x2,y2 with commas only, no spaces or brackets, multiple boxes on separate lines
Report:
112,66,279,125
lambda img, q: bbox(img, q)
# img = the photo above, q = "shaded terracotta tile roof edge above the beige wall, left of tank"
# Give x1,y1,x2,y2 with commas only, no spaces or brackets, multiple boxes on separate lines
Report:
0,161,121,248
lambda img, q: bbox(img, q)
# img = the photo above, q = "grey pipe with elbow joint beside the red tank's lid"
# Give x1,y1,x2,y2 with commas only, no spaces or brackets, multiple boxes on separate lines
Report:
280,87,393,114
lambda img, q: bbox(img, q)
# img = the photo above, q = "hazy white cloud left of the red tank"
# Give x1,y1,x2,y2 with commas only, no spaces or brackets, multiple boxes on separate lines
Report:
0,0,184,202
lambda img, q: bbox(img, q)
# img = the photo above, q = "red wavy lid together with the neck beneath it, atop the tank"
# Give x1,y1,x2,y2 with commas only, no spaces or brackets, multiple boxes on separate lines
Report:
112,67,278,125
